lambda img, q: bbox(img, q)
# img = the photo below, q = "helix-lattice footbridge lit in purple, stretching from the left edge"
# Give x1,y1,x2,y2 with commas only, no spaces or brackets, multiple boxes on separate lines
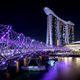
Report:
0,24,80,66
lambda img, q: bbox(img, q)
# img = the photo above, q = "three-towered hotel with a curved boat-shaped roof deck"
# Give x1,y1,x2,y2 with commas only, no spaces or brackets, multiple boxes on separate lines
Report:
44,7,74,46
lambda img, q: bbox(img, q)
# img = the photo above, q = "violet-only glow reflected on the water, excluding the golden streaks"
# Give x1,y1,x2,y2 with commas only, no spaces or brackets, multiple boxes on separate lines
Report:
41,62,69,80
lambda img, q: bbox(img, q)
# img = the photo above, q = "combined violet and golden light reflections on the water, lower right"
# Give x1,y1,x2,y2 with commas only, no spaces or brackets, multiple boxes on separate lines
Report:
42,57,80,80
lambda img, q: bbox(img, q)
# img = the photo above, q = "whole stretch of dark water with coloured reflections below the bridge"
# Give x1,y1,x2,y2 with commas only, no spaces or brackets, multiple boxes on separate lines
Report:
0,57,80,80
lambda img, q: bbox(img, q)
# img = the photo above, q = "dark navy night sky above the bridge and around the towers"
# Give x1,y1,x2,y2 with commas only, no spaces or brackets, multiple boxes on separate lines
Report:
0,0,80,42
